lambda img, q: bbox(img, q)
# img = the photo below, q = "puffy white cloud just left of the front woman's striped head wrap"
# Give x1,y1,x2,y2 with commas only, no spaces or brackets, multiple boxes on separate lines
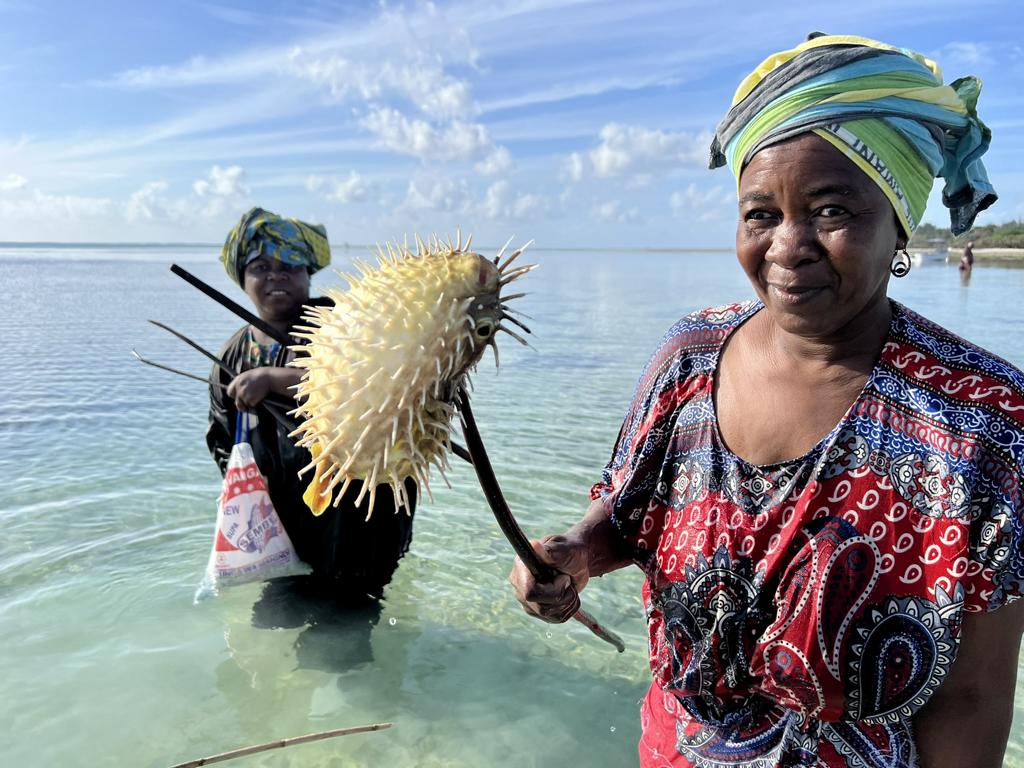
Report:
590,123,711,178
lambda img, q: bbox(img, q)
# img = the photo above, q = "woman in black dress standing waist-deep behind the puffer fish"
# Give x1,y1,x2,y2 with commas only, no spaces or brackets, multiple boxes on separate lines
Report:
206,208,416,604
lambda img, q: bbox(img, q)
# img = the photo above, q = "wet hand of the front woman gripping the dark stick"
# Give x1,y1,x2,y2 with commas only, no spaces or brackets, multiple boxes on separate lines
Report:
509,536,590,624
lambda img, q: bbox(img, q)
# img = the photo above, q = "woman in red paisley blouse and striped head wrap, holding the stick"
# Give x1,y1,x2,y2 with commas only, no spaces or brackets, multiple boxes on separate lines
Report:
510,36,1024,768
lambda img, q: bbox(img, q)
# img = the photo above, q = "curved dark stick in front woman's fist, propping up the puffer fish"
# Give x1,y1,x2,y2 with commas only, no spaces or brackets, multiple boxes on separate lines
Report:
458,389,626,653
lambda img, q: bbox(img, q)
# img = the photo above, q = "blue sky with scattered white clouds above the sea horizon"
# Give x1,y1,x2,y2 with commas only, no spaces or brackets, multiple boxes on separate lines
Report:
0,0,1024,248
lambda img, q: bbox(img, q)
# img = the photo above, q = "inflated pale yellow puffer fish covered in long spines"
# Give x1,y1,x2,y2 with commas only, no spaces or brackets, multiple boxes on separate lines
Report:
291,232,536,519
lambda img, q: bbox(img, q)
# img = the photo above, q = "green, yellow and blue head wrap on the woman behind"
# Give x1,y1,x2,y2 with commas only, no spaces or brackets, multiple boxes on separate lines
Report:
220,208,331,286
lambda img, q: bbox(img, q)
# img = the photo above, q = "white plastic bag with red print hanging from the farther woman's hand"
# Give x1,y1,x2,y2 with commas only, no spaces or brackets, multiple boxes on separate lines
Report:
196,413,308,600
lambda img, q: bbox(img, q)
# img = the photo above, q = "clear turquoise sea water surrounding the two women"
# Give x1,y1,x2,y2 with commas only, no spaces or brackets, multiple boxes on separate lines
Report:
0,248,1024,768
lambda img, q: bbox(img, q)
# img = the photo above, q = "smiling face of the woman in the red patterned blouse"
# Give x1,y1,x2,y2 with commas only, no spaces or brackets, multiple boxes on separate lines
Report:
736,133,906,340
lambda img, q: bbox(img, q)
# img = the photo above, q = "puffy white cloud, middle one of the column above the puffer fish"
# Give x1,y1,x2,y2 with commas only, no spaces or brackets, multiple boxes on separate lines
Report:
362,106,490,160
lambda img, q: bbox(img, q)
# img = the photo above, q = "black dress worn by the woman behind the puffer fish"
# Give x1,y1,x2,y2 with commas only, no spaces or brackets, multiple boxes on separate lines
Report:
206,299,417,602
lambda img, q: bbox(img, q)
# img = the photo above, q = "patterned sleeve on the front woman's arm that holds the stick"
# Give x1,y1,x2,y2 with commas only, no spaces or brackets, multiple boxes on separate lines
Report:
591,315,704,563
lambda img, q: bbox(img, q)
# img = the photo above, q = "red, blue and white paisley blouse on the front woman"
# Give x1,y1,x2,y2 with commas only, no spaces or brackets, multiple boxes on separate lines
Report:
593,302,1024,768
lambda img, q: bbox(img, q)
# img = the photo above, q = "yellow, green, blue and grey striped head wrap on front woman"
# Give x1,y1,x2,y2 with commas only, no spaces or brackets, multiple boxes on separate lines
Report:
711,35,996,234
